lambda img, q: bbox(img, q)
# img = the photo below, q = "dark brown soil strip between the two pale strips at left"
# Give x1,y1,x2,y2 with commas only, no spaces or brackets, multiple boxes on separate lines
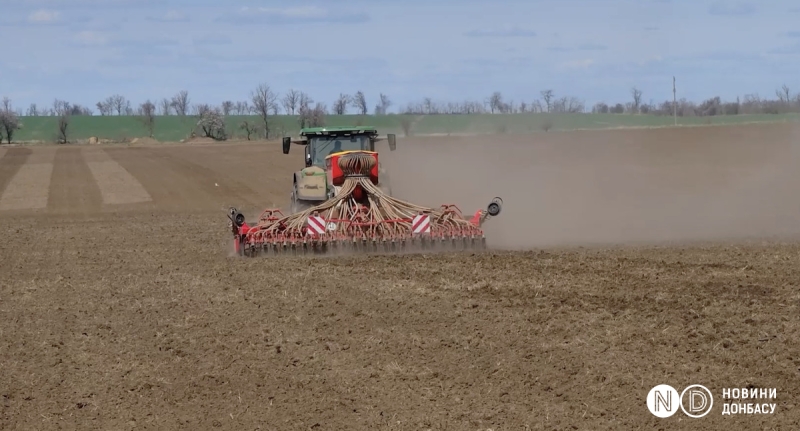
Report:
47,148,103,215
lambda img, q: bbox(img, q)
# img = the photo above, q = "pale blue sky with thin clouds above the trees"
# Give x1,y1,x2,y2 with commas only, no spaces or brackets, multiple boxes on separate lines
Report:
0,0,800,110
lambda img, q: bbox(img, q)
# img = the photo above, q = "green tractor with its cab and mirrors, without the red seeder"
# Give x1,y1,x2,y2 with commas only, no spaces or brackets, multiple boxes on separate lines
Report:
283,127,397,214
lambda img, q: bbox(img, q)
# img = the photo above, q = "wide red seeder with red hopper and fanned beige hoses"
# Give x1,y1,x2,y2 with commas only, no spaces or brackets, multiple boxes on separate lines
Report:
228,127,502,256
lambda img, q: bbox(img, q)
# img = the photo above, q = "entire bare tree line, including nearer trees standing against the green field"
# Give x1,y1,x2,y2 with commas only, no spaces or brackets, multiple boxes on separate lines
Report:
0,84,800,143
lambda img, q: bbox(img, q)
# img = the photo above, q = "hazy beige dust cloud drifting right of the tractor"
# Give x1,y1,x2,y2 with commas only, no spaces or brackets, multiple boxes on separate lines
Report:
381,124,800,249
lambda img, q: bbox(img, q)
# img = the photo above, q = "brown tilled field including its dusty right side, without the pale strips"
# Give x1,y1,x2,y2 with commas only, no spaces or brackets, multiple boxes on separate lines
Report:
0,125,800,430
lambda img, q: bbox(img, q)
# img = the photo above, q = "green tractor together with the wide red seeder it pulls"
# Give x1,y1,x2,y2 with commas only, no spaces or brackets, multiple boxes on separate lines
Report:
228,127,503,257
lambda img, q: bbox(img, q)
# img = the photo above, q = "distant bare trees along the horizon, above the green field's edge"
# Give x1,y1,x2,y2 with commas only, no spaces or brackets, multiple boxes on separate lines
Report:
6,84,800,116
